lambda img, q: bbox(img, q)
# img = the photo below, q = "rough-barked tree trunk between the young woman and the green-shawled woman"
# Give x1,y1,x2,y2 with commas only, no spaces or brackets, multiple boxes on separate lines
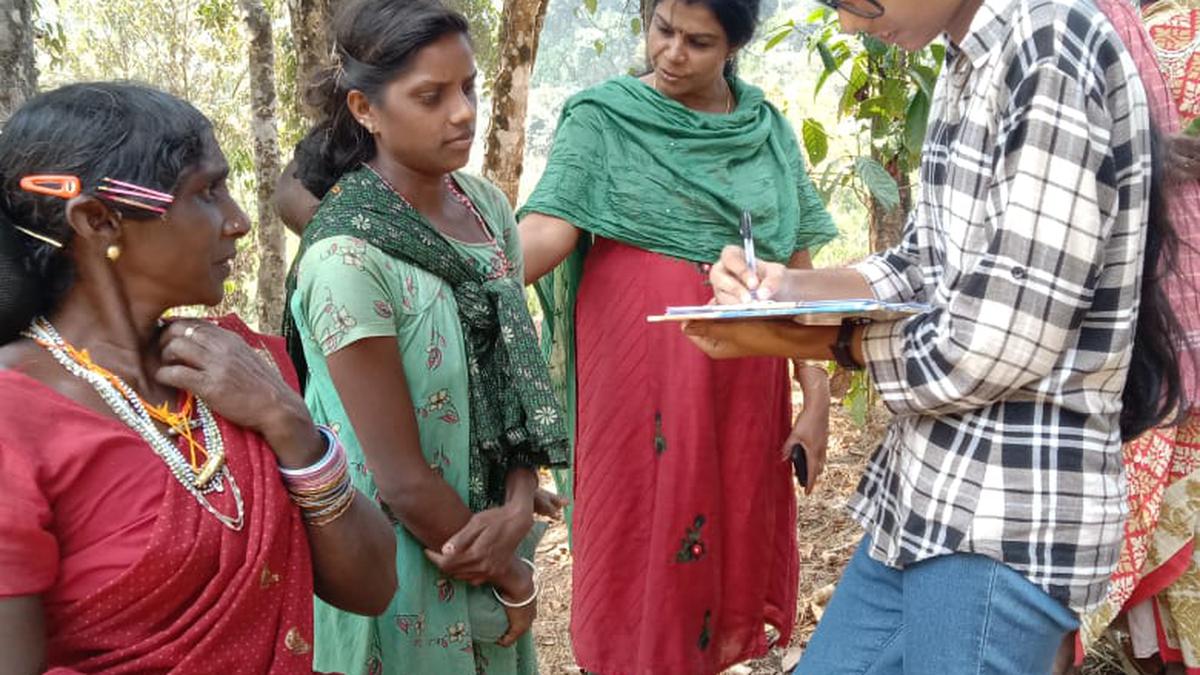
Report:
484,0,550,205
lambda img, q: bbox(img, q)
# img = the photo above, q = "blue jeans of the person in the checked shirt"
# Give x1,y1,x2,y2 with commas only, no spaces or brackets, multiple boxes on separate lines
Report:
796,537,1079,675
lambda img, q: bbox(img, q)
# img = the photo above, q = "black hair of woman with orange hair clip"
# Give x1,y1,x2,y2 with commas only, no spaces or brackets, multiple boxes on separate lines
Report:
0,82,212,345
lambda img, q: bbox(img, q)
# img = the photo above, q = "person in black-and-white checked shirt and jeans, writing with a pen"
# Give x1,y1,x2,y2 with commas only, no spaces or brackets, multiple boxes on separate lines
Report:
684,0,1180,675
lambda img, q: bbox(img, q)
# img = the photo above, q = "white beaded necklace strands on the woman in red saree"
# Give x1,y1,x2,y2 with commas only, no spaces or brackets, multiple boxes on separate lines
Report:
23,317,245,531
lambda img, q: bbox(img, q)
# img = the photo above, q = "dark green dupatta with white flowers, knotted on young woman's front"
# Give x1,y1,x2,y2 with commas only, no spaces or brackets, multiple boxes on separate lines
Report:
283,167,568,512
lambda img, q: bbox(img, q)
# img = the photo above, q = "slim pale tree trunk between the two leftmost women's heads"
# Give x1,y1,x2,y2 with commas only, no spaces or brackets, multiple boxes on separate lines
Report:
241,0,284,331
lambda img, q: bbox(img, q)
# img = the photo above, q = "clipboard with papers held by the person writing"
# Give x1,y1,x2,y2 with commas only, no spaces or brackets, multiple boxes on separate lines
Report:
646,299,930,325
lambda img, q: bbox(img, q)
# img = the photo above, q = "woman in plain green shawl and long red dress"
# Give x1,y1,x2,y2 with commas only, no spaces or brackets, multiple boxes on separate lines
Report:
520,0,836,674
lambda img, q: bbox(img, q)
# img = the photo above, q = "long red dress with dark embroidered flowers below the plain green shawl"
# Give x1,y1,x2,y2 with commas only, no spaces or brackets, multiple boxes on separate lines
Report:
571,238,799,675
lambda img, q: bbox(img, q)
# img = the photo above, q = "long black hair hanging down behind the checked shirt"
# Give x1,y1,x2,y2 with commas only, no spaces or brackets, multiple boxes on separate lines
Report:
1121,126,1187,441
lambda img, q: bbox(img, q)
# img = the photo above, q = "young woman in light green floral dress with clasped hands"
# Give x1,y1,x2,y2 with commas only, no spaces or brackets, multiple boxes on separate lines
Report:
284,0,568,675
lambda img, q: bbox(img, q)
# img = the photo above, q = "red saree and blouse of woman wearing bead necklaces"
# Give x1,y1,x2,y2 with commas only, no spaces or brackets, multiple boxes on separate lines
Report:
0,318,312,675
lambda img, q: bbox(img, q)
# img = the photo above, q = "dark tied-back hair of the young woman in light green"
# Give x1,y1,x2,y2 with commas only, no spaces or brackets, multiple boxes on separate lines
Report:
295,0,469,198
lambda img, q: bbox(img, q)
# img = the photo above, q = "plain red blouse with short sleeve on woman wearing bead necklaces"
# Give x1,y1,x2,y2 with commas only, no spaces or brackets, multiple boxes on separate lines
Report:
0,370,167,616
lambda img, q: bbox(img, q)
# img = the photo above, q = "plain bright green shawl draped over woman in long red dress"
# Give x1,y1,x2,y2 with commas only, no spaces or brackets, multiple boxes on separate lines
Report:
518,76,838,526
